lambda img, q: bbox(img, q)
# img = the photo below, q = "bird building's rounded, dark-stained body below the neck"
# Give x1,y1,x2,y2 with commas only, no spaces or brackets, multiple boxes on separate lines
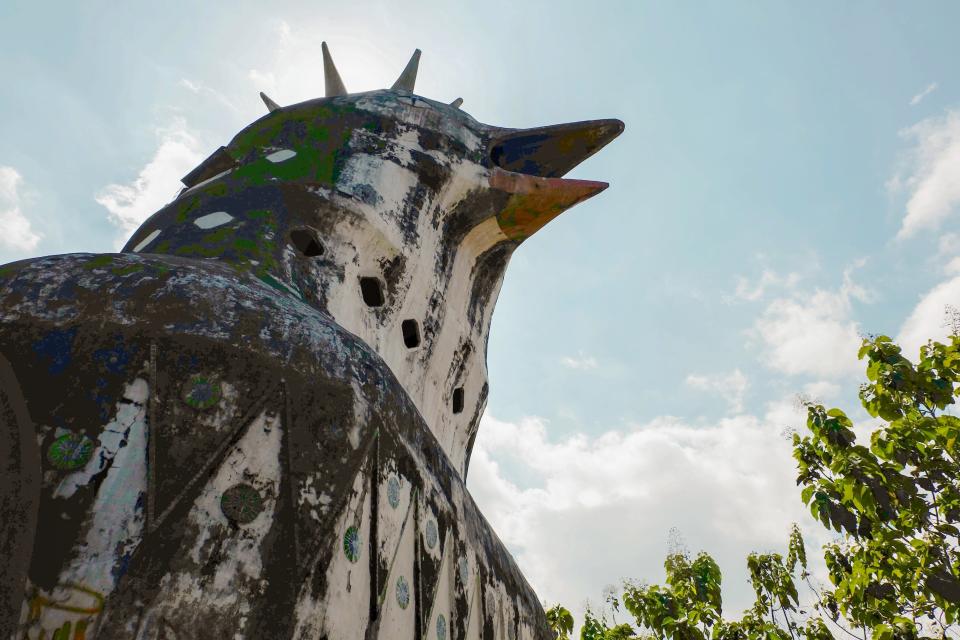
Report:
0,254,544,638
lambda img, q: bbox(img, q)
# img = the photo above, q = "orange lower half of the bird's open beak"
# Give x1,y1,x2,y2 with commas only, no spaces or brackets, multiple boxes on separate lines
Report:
490,168,610,242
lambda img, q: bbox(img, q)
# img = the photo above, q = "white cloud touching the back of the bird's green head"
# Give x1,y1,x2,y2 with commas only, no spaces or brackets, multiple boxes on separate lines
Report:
95,120,203,248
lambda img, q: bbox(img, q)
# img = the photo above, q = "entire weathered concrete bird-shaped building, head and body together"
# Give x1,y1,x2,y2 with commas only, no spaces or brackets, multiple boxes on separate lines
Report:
0,51,622,640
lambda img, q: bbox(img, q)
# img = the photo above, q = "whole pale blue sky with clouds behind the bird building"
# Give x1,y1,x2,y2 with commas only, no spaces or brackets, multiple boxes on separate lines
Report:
0,0,960,632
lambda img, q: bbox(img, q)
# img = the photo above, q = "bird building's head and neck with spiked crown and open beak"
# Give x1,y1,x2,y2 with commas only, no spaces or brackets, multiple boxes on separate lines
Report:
124,43,623,474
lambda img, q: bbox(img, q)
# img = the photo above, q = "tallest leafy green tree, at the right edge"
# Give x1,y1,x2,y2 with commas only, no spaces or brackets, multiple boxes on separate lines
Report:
793,335,960,638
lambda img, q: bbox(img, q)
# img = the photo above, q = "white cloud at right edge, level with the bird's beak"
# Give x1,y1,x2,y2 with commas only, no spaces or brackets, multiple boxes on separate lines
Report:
888,111,960,239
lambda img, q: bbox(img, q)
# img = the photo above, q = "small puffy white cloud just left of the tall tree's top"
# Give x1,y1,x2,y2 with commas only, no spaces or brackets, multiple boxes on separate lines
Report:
748,262,871,379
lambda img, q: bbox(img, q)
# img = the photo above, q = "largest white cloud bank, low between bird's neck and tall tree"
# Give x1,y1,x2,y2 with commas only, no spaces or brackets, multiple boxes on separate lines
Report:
469,411,828,621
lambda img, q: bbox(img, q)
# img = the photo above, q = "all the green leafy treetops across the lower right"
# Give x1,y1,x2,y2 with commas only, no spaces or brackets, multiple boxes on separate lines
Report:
551,329,960,640
